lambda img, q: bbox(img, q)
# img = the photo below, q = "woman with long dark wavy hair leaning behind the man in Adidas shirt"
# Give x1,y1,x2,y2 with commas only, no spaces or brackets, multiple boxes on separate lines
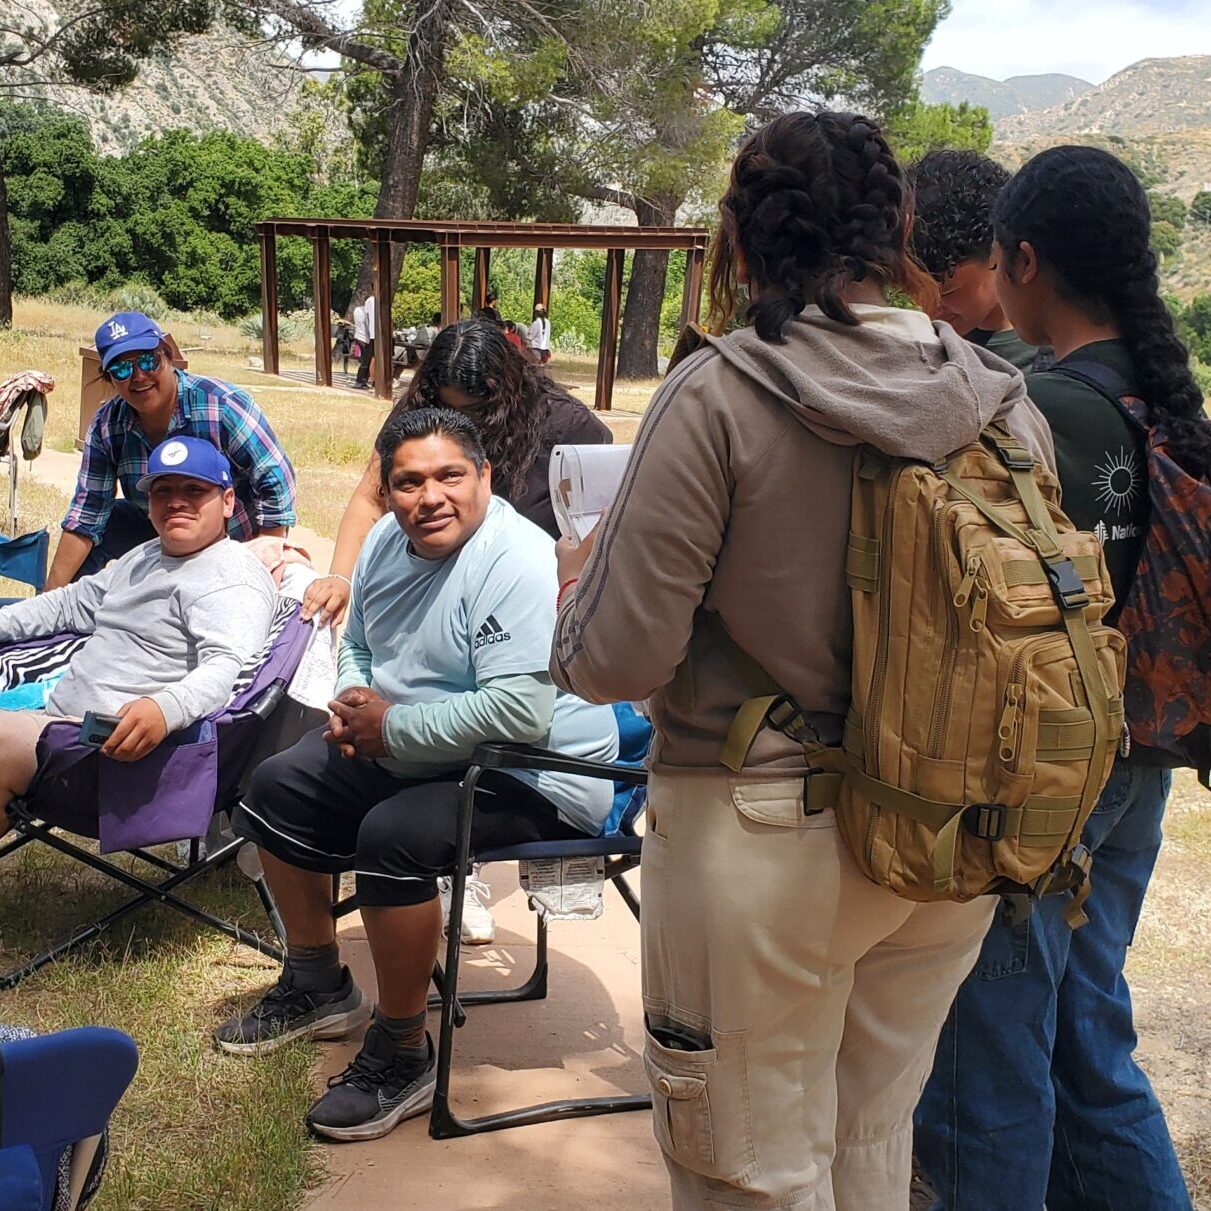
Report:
303,320,613,622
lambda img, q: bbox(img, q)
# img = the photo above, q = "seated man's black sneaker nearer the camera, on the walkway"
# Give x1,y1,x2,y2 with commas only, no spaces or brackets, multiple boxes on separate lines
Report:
306,1023,437,1140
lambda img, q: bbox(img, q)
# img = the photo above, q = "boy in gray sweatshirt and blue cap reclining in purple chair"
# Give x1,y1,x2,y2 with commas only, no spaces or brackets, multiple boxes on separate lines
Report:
0,437,274,808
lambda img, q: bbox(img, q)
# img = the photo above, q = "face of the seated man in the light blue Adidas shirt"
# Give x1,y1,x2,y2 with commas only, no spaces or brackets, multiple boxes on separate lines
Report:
386,435,492,559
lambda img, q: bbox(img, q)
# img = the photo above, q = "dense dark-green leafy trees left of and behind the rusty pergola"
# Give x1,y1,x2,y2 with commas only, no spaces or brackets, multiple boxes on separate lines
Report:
6,109,374,317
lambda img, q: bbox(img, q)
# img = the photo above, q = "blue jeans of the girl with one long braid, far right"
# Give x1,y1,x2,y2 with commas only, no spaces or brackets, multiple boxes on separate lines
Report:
914,761,1190,1211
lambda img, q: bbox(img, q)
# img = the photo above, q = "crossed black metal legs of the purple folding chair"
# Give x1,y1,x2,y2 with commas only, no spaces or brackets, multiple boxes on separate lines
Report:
0,683,286,991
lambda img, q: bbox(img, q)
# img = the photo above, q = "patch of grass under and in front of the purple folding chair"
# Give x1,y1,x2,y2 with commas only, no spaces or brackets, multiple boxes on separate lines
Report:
0,846,321,1211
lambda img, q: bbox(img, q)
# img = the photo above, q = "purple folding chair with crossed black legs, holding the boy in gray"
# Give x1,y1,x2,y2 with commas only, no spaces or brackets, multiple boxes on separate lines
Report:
0,597,316,989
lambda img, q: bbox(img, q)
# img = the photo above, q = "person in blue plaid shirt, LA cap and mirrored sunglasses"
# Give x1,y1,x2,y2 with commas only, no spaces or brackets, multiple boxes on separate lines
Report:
46,311,295,590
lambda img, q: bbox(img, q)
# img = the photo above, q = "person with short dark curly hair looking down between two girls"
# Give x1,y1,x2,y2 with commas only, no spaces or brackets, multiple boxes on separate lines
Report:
908,151,1039,372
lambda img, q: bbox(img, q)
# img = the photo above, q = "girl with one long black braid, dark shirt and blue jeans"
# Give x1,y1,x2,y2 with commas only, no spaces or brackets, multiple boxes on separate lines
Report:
917,147,1196,1211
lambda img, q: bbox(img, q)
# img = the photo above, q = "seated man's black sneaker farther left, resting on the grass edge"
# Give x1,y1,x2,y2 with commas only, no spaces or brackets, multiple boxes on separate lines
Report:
214,968,372,1055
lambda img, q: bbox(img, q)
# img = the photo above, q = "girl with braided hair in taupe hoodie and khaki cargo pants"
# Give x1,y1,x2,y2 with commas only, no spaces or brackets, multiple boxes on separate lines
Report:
551,113,1051,1211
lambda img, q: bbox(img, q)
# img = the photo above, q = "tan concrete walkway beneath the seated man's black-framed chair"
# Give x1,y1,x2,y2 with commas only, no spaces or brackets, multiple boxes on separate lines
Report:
300,866,670,1211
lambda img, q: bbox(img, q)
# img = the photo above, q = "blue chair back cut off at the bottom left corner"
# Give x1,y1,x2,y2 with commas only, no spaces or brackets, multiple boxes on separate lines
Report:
0,1026,139,1211
